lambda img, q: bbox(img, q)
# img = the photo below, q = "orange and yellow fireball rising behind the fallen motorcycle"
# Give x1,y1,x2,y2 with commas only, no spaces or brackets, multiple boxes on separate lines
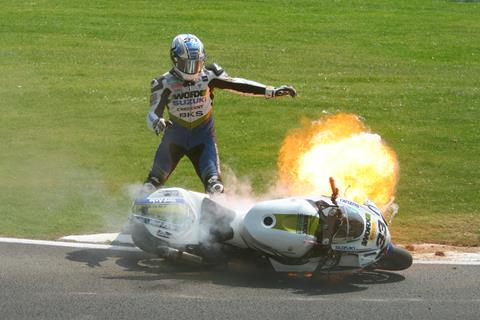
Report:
278,113,399,208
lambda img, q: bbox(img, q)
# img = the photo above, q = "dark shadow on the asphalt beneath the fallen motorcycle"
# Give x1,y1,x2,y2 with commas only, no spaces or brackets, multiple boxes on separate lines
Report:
66,249,405,296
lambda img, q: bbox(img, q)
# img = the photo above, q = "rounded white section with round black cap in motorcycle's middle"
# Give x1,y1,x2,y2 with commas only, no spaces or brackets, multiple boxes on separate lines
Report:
240,198,318,258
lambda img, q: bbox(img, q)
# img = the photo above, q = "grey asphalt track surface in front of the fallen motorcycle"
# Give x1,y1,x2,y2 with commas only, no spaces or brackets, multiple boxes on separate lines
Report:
0,243,480,320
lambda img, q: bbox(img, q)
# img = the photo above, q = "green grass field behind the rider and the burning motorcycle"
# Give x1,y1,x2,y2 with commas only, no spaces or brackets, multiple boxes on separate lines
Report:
0,0,480,245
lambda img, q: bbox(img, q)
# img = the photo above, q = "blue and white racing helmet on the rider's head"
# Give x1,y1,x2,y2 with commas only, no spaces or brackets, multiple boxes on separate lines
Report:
170,34,207,81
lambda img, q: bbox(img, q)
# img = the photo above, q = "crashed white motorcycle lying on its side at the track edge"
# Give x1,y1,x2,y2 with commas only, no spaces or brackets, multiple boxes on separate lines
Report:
129,179,412,273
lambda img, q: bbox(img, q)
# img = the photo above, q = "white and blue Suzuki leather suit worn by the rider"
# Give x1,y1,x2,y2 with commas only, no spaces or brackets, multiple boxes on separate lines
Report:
146,64,274,191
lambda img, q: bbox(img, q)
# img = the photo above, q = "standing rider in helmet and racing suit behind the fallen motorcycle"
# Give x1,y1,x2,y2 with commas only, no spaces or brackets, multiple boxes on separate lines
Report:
144,34,296,194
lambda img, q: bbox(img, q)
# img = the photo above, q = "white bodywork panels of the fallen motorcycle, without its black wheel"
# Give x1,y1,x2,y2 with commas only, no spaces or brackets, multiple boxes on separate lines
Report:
131,188,391,272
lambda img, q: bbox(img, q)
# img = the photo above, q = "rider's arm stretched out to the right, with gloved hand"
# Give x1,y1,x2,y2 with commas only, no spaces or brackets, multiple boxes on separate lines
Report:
206,63,297,99
